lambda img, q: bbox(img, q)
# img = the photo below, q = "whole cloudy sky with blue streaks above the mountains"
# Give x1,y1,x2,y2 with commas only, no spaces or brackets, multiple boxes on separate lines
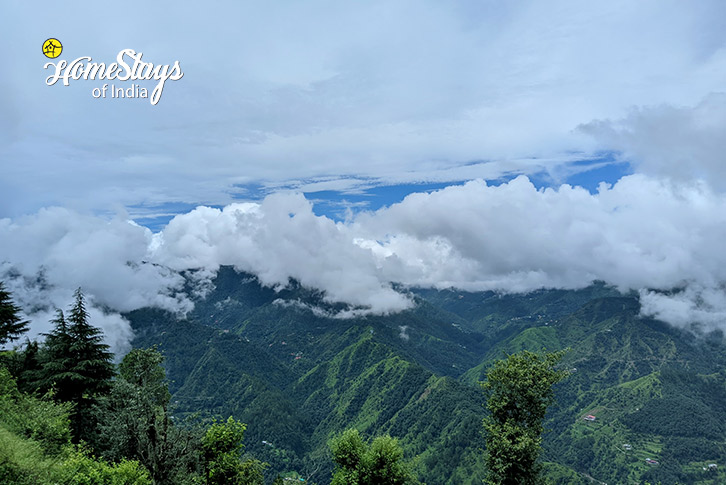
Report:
0,0,726,349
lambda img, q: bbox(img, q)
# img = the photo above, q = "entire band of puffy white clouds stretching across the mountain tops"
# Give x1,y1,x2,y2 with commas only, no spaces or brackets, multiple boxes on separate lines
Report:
0,175,726,352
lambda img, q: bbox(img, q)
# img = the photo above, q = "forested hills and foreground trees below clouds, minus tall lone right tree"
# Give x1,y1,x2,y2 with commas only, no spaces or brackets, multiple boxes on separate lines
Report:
0,267,726,485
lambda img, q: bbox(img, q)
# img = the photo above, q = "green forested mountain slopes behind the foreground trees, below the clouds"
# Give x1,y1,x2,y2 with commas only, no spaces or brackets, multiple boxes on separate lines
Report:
128,268,726,484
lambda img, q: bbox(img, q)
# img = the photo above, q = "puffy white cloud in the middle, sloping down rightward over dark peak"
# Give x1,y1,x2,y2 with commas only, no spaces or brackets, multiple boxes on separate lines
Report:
153,194,410,312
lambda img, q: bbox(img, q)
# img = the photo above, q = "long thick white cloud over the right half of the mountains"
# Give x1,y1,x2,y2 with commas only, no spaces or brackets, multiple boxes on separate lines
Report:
354,175,726,291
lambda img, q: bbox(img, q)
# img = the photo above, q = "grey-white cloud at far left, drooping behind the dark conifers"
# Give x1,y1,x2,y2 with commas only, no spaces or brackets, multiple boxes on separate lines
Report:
0,208,192,353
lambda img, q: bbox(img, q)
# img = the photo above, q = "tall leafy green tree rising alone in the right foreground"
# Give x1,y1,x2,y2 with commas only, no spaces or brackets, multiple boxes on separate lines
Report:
483,350,565,485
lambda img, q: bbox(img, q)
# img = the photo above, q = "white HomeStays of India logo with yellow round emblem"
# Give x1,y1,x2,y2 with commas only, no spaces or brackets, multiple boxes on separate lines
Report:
43,38,184,105
